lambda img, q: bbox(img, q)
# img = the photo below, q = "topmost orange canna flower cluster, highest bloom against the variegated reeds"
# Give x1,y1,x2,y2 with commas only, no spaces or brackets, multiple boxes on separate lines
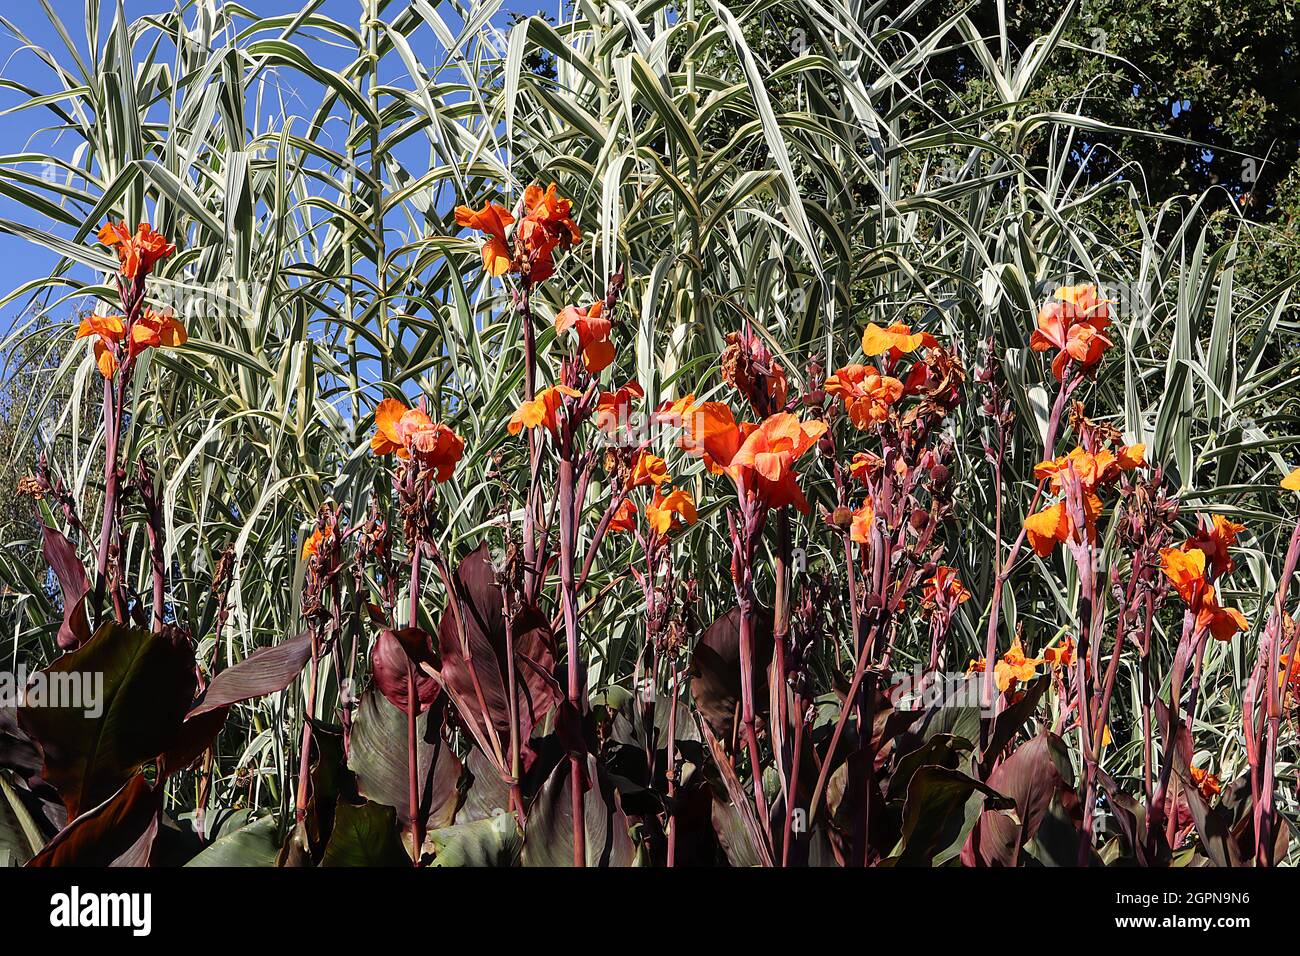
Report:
455,182,582,282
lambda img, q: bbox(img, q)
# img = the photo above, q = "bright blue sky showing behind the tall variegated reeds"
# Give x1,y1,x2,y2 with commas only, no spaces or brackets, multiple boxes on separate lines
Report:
0,0,548,334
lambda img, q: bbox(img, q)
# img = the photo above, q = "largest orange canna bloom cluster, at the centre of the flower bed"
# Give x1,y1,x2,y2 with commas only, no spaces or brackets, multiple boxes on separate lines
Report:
676,397,827,514
